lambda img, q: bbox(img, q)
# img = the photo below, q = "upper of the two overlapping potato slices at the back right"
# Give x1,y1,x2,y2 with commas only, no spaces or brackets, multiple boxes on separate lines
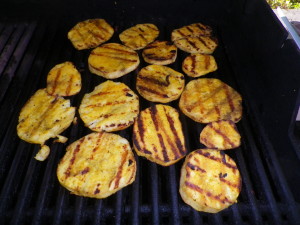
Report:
171,23,212,41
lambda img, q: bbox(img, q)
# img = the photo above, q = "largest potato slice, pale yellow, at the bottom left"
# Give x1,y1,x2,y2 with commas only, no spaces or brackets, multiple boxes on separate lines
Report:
57,132,136,198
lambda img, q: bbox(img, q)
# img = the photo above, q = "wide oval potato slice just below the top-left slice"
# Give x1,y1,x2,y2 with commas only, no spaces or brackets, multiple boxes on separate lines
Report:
88,43,140,79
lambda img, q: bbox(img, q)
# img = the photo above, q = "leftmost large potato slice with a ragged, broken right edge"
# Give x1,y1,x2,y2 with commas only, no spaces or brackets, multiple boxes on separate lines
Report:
17,89,75,145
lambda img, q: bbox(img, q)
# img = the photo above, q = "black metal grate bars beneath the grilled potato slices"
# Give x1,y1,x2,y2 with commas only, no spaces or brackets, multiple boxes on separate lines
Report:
0,3,300,225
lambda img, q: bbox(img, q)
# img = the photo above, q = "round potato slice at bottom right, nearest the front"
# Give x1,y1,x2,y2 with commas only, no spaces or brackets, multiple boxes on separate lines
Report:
179,149,242,213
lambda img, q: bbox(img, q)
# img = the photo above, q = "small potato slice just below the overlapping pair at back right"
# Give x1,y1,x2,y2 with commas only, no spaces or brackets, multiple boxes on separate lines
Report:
182,53,218,77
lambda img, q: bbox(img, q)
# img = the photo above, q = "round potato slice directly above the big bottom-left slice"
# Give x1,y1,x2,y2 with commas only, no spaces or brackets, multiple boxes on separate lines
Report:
79,80,139,132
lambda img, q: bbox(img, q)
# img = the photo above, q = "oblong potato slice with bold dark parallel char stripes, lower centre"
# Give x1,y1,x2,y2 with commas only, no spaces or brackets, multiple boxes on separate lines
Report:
133,105,187,166
